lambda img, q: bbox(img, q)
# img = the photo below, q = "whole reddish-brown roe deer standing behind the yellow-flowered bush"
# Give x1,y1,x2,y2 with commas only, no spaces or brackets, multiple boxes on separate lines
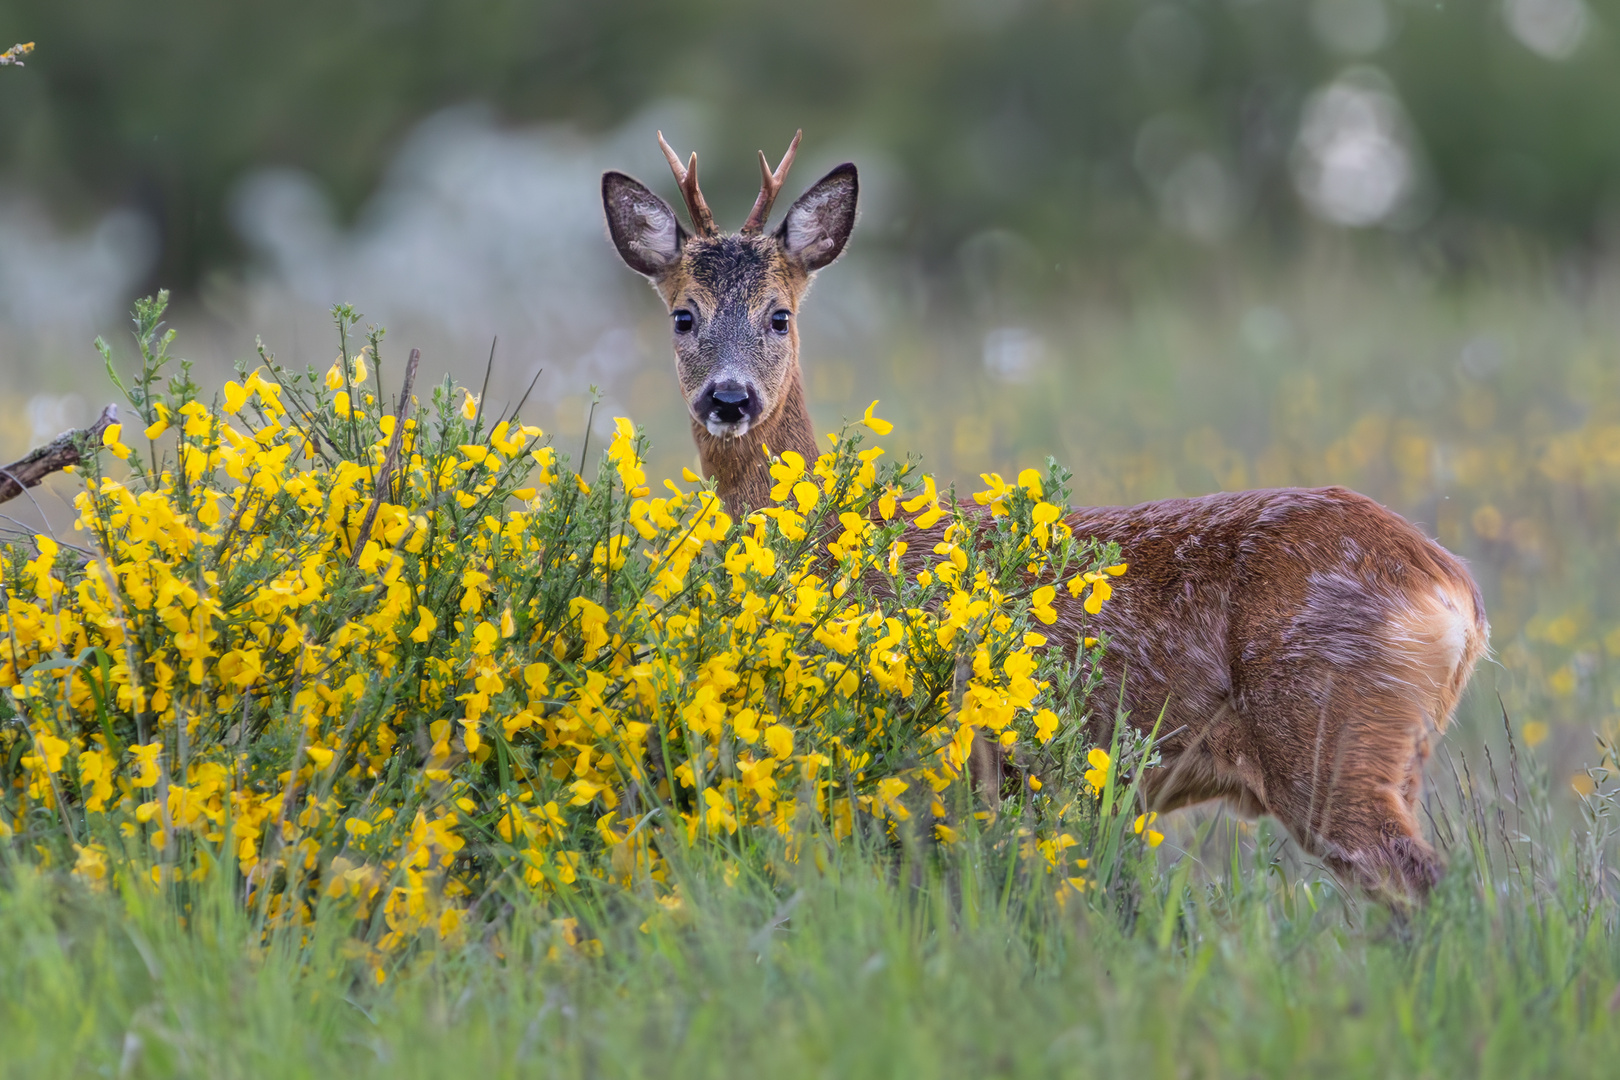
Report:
603,133,1489,897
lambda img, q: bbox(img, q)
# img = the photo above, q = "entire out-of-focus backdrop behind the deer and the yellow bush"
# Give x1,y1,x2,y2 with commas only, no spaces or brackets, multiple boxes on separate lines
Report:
0,0,1620,782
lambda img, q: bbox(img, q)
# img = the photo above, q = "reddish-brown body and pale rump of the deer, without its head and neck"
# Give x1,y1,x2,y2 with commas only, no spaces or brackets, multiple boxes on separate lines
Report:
912,487,1489,895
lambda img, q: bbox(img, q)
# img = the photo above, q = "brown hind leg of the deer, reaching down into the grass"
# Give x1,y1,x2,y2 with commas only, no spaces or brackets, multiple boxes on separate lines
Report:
1256,675,1443,900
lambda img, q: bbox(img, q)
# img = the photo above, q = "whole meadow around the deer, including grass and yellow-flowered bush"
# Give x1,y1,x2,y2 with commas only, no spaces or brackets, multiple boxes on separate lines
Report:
0,251,1620,1077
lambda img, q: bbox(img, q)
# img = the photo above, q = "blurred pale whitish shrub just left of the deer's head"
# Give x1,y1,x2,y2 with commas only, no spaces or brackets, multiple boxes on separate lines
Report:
232,108,625,347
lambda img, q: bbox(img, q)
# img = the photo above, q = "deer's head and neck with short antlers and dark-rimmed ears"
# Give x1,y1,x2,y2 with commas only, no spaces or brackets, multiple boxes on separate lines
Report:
603,131,859,505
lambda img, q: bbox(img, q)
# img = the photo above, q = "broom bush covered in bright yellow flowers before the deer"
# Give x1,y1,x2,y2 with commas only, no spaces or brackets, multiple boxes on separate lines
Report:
0,295,1158,978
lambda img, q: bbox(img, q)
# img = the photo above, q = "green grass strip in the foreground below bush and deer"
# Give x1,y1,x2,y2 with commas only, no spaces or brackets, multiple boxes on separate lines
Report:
0,725,1620,1077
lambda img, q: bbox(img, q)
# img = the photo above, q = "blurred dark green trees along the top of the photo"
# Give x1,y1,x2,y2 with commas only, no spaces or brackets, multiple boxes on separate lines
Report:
9,0,1620,283
